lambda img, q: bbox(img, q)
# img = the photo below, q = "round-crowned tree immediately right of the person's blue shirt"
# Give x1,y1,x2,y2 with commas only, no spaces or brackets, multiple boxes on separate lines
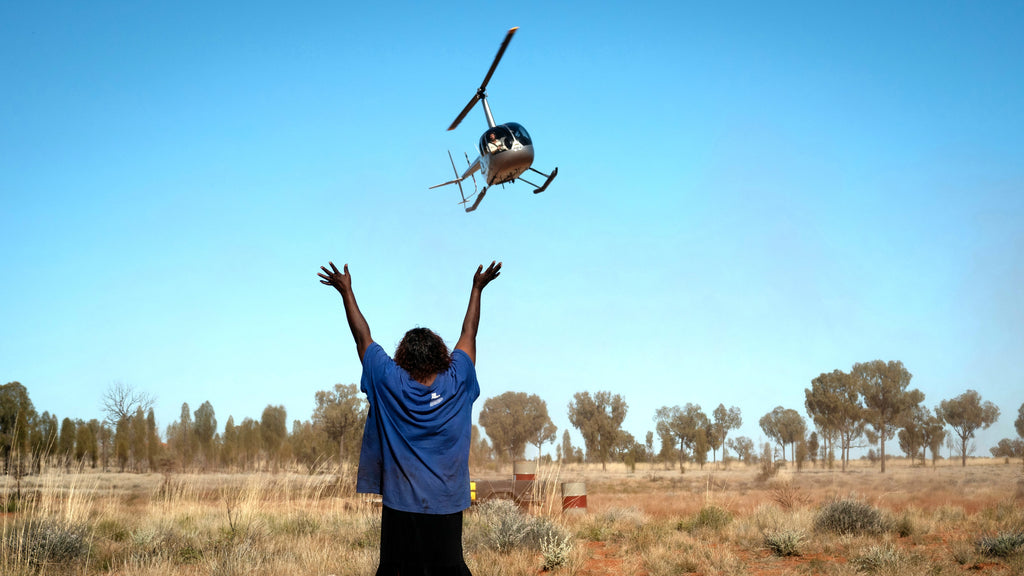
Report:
478,392,554,460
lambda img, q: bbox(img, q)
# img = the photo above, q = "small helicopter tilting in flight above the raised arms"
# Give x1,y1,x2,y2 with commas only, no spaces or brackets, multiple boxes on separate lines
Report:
430,27,558,212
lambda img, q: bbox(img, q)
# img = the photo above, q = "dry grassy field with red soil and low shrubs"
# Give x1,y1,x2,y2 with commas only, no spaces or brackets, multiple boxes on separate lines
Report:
0,459,1024,576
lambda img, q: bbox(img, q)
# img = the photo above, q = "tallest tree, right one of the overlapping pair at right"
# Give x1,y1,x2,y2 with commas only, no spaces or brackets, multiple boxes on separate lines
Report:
851,360,925,474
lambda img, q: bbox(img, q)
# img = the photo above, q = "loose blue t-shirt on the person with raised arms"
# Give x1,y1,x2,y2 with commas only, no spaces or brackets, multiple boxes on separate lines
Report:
355,342,480,515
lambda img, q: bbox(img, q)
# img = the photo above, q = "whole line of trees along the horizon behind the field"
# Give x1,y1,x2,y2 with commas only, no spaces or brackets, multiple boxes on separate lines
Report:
0,360,1024,478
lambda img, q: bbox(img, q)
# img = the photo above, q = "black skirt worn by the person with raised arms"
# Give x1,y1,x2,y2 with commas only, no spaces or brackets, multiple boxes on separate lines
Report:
377,506,471,576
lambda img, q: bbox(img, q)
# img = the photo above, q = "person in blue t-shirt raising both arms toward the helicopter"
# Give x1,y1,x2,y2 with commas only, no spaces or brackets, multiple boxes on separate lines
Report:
317,262,502,576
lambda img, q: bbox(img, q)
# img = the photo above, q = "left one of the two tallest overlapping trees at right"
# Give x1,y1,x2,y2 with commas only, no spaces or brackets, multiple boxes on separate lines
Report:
804,370,866,471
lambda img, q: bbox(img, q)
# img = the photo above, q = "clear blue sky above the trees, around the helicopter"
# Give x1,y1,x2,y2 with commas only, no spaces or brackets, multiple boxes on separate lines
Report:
0,2,1024,455
